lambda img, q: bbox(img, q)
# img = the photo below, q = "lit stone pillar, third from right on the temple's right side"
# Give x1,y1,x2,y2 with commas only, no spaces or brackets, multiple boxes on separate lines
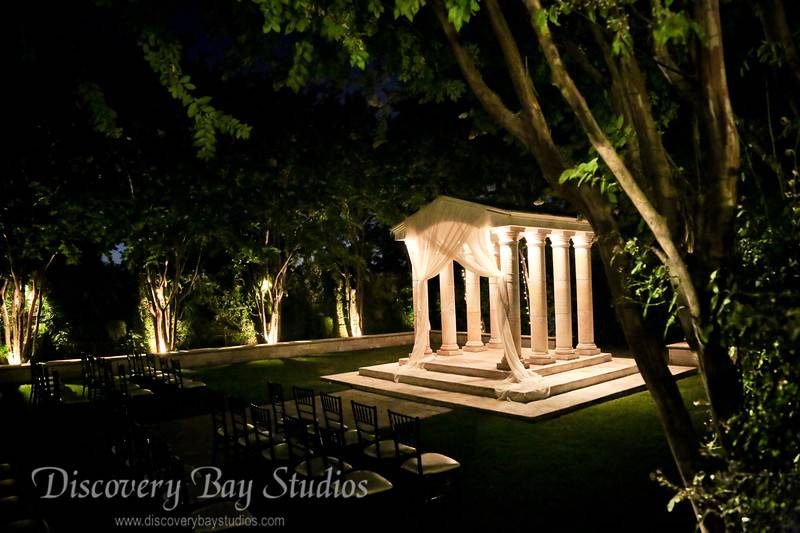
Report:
524,229,554,364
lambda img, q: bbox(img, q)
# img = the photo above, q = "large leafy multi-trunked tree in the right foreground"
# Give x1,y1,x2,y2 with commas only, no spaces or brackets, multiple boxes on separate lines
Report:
234,0,796,527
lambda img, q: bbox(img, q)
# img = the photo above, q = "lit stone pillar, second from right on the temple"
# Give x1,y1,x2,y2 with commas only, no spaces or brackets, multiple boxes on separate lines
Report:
550,230,578,359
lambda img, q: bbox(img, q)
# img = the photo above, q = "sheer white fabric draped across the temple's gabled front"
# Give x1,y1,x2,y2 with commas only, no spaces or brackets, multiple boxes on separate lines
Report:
399,197,549,401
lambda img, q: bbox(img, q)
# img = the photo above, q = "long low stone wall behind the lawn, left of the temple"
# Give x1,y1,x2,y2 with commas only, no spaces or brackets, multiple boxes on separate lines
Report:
0,331,414,385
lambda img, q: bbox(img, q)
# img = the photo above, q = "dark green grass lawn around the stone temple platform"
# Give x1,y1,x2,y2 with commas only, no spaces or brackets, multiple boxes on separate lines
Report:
189,347,705,531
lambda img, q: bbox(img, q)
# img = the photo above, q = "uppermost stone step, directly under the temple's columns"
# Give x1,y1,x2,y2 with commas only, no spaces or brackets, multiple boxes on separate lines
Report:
424,352,611,380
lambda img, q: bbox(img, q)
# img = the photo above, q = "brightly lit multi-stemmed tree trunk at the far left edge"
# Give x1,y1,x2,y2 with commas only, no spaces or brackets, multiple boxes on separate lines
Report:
0,256,55,365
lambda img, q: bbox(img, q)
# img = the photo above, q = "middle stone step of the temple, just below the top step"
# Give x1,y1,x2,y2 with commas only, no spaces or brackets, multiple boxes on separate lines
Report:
358,359,638,398
